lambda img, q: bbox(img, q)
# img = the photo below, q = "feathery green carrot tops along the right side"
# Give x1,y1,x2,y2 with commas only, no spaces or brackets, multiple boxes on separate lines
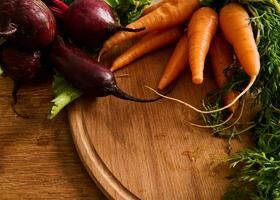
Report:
203,0,280,200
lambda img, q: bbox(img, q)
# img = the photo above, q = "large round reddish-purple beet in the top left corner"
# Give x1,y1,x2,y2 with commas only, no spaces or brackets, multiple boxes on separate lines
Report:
0,0,56,49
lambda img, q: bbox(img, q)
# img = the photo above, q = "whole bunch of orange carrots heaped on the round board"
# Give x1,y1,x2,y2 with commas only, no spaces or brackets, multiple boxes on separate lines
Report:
99,0,260,124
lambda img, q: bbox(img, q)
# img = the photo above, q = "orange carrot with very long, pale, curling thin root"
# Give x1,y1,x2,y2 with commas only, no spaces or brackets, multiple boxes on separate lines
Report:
148,3,260,114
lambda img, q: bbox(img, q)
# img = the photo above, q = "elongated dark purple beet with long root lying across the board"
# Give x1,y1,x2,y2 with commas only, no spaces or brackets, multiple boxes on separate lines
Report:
50,38,159,102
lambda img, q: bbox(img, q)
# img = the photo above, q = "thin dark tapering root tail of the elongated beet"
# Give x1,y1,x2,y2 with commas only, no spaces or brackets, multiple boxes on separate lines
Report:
110,86,161,103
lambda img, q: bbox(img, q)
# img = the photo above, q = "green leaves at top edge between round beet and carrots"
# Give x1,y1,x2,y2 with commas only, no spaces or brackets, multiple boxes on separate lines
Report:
106,0,152,25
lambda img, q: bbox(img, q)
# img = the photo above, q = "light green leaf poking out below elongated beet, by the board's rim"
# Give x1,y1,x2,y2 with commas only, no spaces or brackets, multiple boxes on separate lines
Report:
48,72,82,119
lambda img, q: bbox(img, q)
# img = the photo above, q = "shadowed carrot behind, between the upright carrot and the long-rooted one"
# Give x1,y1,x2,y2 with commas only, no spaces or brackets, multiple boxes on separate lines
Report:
209,34,238,113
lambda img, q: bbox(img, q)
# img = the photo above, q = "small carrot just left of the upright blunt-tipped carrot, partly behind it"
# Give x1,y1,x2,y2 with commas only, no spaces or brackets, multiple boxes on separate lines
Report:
158,34,188,90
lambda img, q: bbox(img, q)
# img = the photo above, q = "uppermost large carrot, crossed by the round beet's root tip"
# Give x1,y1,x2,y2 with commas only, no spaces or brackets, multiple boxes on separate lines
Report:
98,0,199,60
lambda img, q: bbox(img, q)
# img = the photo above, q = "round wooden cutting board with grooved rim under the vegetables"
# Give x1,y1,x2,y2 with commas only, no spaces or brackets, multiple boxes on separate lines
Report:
69,47,247,200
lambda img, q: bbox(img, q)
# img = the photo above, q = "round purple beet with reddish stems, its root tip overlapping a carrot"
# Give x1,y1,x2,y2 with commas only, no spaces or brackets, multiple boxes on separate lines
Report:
48,0,144,48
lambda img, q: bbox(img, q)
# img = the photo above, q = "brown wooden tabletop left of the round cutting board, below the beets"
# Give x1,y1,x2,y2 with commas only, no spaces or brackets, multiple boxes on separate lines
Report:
0,77,105,200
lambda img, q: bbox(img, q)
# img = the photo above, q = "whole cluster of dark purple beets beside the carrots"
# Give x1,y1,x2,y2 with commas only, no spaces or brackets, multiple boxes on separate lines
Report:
0,0,155,117
